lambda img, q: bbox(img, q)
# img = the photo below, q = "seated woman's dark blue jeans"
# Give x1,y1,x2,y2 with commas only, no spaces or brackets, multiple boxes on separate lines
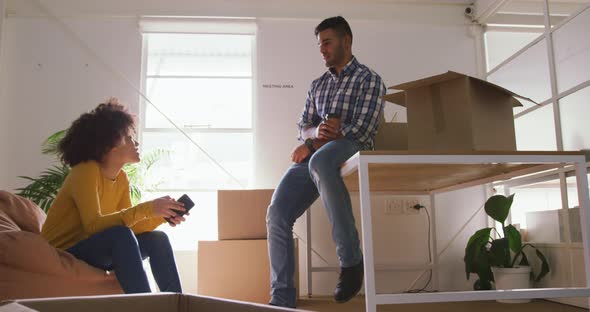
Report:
66,226,182,294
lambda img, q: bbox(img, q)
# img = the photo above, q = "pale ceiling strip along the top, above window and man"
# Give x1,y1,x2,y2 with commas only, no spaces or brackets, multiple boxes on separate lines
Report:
6,0,473,24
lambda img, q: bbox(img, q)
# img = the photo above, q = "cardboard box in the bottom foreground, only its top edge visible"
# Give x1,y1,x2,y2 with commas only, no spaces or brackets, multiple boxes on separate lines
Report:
2,293,303,312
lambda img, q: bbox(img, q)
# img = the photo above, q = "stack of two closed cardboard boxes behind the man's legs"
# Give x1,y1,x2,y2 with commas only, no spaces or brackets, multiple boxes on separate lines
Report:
197,190,299,303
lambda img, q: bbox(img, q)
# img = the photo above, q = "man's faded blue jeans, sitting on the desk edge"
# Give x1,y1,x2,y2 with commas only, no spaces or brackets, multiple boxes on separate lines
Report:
266,139,362,307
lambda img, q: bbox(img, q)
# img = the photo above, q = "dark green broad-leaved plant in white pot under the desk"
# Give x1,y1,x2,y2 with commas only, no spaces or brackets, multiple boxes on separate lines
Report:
464,194,549,290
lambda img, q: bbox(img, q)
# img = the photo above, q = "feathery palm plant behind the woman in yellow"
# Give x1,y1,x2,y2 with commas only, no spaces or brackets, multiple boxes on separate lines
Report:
17,129,167,213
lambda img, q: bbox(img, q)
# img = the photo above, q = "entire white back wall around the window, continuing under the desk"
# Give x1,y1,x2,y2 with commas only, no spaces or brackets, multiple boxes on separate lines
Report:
0,0,483,294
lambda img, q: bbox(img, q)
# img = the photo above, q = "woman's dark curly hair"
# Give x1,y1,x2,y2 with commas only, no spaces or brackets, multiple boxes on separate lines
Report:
58,98,135,166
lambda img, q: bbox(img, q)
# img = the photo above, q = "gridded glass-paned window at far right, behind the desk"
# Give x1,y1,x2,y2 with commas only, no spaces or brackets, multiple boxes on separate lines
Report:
485,0,590,243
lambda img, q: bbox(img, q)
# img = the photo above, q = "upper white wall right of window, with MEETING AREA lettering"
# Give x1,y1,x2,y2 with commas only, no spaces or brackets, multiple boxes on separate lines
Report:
255,17,476,188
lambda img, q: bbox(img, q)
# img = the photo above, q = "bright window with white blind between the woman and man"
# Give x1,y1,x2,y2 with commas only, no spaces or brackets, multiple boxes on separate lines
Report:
140,22,255,250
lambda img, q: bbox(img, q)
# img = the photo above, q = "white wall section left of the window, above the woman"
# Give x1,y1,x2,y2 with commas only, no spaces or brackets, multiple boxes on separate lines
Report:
2,18,141,190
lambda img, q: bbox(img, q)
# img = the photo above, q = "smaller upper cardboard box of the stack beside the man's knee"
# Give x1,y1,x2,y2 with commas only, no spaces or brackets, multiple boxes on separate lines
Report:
217,190,274,240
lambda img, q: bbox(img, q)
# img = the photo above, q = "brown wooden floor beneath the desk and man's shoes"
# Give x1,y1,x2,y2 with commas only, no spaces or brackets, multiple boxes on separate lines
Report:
297,296,588,312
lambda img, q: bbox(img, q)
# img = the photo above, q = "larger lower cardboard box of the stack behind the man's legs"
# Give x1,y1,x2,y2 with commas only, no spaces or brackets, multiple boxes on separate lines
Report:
197,239,299,303
